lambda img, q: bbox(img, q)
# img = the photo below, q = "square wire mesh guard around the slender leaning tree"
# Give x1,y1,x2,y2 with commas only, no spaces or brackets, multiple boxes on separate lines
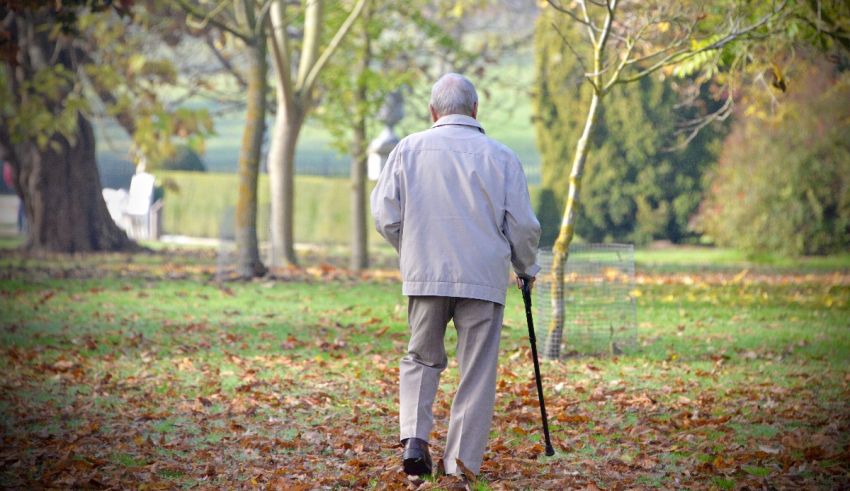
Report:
534,244,637,358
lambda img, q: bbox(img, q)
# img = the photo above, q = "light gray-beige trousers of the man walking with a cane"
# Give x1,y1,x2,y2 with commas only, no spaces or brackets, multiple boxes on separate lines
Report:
399,296,505,474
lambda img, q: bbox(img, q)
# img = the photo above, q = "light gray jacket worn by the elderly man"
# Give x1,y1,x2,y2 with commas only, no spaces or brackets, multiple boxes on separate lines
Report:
372,114,540,304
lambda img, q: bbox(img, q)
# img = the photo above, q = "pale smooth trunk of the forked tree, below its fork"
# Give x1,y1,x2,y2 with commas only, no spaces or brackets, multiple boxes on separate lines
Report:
268,101,304,267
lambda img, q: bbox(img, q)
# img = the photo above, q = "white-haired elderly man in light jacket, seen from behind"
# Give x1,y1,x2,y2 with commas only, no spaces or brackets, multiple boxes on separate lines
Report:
371,73,540,475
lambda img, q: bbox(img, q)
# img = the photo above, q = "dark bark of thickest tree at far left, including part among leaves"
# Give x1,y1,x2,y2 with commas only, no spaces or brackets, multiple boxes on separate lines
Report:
0,8,132,253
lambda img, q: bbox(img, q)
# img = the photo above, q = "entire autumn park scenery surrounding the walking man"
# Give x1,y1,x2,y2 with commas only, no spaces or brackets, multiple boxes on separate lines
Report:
0,0,850,490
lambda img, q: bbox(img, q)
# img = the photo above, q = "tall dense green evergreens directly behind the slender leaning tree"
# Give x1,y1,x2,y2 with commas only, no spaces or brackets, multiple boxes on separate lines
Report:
532,13,722,243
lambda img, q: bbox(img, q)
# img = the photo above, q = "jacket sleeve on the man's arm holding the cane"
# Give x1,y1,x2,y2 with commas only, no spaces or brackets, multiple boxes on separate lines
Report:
503,161,540,278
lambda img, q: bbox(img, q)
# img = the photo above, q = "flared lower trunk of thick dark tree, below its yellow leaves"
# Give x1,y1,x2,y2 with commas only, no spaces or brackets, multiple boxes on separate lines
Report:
0,114,138,253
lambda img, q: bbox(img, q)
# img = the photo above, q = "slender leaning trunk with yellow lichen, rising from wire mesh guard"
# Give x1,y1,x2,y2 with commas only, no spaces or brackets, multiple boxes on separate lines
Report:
543,91,600,359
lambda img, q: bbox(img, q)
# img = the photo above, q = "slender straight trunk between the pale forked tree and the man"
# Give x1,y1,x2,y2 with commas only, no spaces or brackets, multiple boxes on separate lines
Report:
349,17,372,271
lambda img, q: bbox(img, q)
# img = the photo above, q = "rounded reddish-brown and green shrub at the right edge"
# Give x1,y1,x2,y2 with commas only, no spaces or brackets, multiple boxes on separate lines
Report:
699,62,850,256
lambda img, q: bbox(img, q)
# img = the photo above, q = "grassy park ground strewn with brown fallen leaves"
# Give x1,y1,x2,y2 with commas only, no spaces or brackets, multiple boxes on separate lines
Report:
0,251,850,489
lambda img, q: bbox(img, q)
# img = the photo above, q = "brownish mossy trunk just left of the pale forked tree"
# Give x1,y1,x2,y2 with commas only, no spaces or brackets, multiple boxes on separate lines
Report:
235,37,268,278
